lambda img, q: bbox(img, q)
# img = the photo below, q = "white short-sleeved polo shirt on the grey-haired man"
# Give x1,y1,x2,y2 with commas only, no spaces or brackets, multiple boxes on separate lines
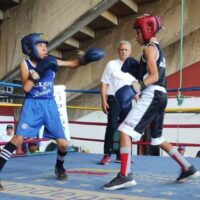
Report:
101,59,136,95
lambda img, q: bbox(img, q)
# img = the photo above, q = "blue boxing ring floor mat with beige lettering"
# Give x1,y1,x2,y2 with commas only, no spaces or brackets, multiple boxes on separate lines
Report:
0,152,200,200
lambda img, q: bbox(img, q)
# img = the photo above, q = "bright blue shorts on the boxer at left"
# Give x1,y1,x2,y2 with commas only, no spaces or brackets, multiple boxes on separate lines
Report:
16,98,66,139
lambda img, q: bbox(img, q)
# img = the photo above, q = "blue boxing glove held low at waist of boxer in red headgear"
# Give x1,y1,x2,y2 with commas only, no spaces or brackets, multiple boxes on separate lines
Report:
115,85,136,112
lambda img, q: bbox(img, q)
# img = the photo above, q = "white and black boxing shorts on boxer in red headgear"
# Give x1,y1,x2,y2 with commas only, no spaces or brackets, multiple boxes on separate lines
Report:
118,85,167,145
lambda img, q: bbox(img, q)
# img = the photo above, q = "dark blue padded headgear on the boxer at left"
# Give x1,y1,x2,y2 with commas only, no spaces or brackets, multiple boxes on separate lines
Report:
21,33,48,60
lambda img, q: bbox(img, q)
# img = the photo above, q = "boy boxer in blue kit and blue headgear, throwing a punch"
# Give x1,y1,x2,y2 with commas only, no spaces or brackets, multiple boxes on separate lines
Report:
0,33,104,188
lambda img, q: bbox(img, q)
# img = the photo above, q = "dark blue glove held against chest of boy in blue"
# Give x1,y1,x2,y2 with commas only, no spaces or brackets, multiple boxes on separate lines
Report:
29,56,58,84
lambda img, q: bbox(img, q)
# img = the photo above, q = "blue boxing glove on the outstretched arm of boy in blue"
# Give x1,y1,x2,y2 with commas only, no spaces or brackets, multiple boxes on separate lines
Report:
79,47,105,65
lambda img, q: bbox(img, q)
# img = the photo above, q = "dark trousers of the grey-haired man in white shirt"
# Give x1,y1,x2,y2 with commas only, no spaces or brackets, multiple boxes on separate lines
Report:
104,95,132,154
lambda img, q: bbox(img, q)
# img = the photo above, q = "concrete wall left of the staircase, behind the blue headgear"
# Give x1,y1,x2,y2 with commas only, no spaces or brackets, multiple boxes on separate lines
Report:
0,0,101,78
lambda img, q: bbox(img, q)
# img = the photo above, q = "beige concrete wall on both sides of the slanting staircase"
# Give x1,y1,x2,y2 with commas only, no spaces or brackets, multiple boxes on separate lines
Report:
0,0,200,89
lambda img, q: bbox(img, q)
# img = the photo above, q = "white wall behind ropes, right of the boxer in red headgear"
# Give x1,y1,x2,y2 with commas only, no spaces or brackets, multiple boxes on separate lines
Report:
161,97,200,157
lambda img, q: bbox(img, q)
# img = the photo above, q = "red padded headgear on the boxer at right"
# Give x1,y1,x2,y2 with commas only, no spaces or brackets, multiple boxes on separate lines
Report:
133,14,162,42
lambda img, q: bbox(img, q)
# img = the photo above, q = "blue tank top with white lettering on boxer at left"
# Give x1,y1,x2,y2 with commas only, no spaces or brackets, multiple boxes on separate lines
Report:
25,60,55,99
